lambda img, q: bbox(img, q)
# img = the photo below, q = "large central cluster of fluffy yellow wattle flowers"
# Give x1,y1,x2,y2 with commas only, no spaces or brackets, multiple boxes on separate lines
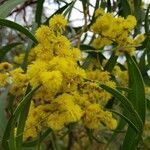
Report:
0,15,117,140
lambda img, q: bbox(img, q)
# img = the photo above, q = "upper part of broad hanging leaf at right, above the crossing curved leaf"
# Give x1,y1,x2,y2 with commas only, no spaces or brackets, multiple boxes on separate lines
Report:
126,55,146,123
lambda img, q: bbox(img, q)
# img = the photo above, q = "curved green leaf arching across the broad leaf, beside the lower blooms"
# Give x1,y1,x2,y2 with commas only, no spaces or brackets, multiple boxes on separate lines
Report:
100,85,143,132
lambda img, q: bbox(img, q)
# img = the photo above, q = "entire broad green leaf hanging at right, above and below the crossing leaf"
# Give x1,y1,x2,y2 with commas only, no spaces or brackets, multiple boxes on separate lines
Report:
123,54,146,150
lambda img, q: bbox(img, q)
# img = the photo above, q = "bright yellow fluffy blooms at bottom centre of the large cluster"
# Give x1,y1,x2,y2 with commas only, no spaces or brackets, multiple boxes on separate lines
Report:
47,94,82,130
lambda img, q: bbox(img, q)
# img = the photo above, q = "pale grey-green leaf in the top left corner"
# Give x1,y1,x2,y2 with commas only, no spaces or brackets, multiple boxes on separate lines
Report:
0,0,26,18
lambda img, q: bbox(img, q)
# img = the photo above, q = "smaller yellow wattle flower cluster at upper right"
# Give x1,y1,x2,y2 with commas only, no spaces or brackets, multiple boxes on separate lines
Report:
91,9,144,55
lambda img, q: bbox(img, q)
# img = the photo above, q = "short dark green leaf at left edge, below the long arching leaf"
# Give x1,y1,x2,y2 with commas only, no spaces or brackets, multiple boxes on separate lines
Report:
0,43,22,61
